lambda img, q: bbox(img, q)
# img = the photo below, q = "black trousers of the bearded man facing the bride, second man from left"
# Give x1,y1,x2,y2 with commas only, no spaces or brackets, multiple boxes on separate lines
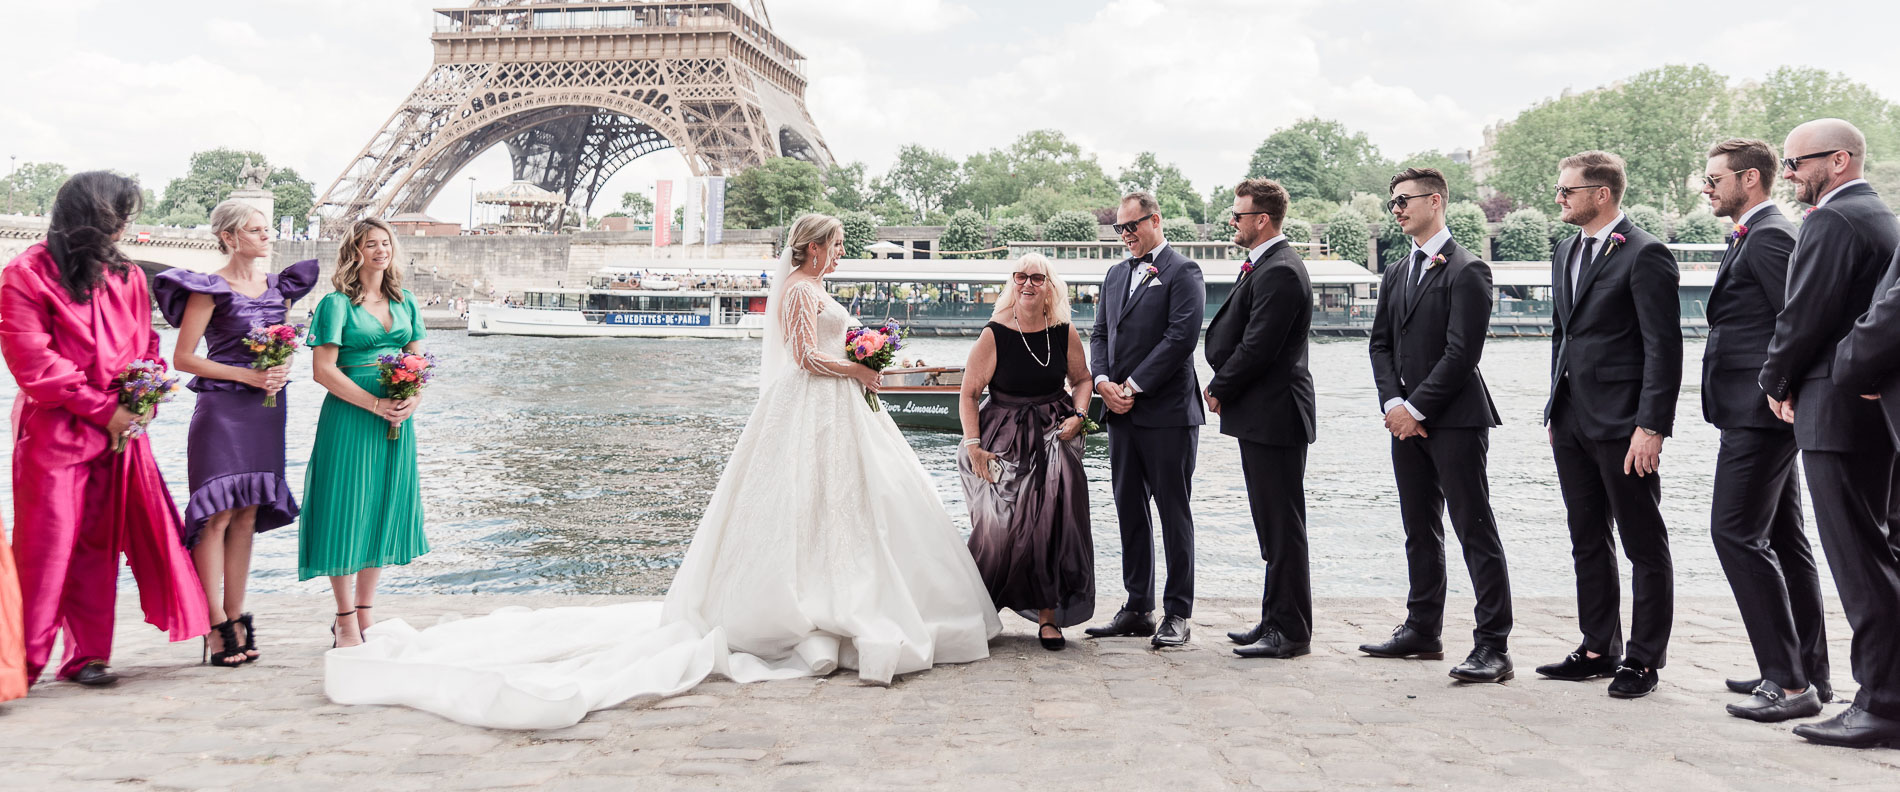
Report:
1241,441,1313,644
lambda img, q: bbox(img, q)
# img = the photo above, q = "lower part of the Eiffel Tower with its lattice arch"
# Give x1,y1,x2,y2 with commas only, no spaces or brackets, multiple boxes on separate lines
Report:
314,0,832,236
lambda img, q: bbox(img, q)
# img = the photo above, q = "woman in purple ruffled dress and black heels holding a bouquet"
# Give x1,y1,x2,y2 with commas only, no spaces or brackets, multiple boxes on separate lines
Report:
156,201,317,667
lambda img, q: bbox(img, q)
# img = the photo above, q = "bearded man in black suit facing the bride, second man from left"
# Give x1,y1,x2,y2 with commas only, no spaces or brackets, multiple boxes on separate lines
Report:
1203,179,1317,659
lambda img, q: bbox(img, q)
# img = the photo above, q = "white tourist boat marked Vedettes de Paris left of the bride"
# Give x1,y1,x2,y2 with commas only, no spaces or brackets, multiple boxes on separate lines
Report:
469,270,768,338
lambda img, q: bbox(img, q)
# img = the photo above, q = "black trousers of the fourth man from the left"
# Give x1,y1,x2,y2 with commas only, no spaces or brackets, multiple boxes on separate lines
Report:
1552,397,1676,669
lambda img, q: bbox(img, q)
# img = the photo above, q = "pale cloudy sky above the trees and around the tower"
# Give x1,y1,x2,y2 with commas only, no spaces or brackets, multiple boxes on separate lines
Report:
0,0,1900,220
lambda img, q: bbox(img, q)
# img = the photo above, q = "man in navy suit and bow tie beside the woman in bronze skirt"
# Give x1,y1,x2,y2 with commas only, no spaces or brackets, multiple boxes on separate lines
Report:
1085,192,1207,646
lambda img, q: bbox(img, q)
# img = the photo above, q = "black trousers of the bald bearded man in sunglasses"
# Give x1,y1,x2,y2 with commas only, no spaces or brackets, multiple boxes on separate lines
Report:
1801,448,1900,718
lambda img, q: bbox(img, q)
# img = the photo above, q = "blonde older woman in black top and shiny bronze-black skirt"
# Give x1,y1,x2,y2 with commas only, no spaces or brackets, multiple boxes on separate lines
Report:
958,253,1094,650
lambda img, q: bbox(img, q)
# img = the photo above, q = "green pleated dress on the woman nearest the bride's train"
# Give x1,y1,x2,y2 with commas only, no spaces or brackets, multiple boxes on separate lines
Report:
296,289,429,579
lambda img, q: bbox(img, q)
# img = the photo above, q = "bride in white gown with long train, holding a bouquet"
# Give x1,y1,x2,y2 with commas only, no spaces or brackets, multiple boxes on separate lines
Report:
325,215,1001,729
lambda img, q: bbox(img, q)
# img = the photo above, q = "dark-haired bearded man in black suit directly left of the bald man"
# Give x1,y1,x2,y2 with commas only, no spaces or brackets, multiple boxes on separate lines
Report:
1702,139,1834,722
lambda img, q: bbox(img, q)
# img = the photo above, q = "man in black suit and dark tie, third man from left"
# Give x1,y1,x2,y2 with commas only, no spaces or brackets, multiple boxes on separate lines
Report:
1359,167,1514,682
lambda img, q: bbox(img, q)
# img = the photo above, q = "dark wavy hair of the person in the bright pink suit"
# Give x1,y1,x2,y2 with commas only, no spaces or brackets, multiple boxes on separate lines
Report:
46,171,144,302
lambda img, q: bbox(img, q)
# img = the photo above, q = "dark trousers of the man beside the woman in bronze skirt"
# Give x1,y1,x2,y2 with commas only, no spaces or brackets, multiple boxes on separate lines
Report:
1108,420,1201,619
